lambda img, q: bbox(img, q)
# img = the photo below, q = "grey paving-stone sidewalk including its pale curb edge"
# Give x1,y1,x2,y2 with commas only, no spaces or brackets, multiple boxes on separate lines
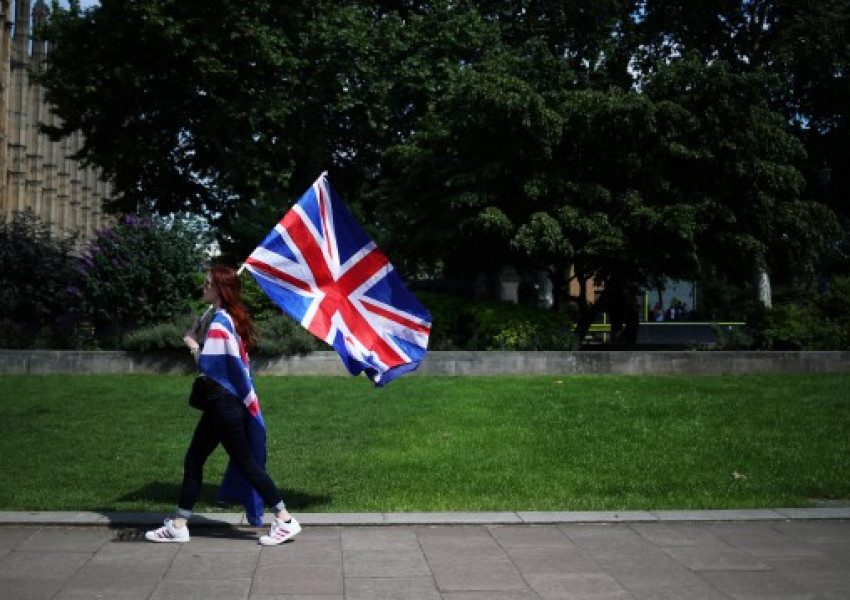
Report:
0,509,850,600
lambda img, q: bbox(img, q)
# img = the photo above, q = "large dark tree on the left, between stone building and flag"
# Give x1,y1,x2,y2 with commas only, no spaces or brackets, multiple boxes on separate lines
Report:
40,0,487,268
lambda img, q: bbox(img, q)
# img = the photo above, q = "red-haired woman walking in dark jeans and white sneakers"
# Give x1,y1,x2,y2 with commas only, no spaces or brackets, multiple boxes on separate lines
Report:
145,267,301,546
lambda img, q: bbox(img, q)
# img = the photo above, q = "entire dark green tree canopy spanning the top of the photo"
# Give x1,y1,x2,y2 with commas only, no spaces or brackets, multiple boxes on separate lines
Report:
41,0,850,338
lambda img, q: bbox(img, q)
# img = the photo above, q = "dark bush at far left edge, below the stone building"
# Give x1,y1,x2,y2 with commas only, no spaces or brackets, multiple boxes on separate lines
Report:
0,211,84,348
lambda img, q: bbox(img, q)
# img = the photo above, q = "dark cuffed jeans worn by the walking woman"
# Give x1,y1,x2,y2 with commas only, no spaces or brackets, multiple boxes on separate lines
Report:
177,383,281,511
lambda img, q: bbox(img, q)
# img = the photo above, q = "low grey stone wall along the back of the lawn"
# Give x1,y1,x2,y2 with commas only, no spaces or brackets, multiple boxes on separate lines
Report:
0,350,850,375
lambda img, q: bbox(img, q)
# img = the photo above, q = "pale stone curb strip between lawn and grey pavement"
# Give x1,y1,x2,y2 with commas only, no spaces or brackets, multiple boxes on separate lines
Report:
0,507,850,527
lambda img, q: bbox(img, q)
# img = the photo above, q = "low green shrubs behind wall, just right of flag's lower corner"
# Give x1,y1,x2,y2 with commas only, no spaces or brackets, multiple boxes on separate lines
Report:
418,293,575,350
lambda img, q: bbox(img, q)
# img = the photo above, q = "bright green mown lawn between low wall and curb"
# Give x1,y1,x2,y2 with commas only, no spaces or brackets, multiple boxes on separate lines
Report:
0,374,850,512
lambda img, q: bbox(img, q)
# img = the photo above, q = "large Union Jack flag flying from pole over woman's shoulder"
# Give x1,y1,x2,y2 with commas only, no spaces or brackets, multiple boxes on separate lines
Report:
245,173,431,386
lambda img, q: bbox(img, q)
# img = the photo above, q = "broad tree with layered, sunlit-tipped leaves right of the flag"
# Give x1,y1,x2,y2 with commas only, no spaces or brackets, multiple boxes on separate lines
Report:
378,8,834,342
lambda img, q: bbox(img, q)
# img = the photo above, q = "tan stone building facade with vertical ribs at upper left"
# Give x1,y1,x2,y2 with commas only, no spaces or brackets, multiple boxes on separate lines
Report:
0,0,114,243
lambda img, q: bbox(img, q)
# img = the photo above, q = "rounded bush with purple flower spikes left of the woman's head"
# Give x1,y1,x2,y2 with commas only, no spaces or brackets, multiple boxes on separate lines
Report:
81,218,204,347
